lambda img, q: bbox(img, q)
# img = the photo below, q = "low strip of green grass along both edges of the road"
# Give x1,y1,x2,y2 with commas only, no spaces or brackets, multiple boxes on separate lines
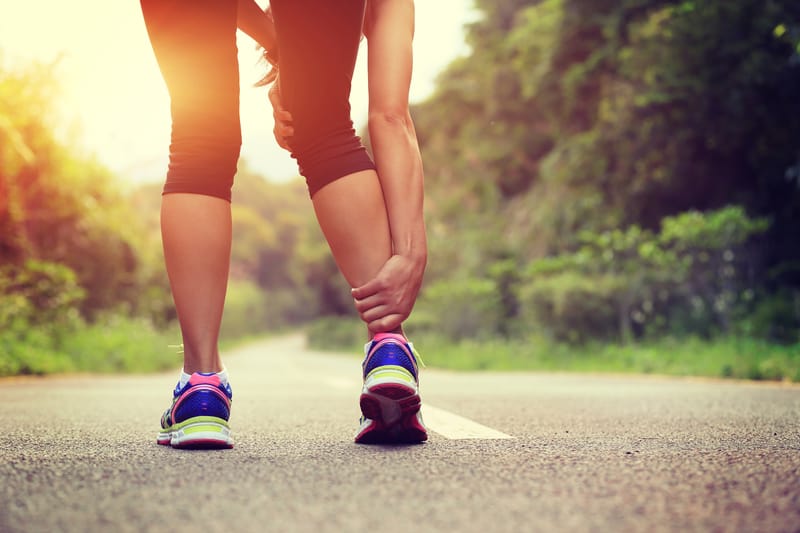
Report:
0,317,800,382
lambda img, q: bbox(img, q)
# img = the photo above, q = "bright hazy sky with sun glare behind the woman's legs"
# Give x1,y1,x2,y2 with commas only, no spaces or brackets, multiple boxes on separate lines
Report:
0,0,475,182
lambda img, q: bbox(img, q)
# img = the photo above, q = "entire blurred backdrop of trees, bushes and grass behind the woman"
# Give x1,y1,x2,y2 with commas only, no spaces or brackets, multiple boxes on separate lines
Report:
0,0,800,381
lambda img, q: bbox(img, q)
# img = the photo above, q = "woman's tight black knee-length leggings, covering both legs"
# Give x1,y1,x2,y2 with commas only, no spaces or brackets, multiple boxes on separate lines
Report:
141,0,375,201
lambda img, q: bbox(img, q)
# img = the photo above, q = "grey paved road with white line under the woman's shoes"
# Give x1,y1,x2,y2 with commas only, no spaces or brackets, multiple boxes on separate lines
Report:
0,337,800,533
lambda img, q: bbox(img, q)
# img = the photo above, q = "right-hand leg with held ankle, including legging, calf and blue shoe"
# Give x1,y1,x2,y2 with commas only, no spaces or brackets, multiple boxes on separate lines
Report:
271,0,428,444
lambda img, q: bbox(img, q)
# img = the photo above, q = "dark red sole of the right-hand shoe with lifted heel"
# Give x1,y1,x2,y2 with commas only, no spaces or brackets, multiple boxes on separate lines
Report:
355,383,428,444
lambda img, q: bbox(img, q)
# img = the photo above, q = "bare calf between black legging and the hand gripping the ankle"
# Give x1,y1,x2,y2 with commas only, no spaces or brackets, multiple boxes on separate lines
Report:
312,170,402,334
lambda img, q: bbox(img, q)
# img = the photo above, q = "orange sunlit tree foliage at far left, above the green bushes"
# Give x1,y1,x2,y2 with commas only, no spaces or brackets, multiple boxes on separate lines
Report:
0,57,166,320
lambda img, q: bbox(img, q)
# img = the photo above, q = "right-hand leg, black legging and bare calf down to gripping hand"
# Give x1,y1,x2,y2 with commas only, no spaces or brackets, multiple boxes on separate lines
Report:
271,0,399,333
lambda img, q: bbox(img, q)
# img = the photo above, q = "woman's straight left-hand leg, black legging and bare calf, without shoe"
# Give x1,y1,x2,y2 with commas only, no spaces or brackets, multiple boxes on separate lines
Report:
141,0,241,374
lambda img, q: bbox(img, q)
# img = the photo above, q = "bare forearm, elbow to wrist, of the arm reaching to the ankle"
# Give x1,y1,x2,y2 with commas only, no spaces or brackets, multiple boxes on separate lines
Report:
369,111,428,266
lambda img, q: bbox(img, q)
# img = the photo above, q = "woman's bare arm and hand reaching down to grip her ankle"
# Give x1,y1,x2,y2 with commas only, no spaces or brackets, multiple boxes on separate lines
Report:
353,0,428,331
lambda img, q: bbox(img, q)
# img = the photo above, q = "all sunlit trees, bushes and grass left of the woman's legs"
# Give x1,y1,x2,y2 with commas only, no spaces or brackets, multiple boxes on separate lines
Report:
0,59,183,375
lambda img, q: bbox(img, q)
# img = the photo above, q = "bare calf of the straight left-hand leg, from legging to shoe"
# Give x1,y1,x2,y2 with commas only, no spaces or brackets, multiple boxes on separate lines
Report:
161,193,231,374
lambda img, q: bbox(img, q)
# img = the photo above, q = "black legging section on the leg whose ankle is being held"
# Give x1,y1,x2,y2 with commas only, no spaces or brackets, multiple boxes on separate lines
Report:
270,0,375,196
